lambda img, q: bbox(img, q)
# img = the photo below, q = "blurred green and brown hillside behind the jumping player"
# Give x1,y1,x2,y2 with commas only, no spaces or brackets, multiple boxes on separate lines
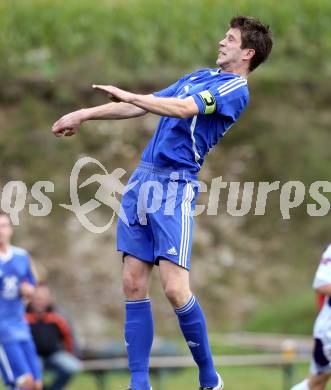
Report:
0,0,331,338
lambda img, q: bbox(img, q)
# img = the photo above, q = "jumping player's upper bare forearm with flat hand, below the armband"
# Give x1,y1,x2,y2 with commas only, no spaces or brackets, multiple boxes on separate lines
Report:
93,85,199,118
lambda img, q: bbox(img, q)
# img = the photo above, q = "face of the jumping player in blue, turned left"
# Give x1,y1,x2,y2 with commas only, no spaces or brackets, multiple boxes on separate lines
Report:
216,28,245,70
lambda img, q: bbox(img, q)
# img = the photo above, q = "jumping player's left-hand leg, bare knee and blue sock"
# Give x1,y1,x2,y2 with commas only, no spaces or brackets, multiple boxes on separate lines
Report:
123,256,154,390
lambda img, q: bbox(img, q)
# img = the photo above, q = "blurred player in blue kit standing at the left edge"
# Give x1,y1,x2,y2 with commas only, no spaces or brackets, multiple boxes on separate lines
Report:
0,213,42,390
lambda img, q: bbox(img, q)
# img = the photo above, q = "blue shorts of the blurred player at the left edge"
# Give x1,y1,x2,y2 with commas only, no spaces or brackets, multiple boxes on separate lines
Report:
0,339,42,387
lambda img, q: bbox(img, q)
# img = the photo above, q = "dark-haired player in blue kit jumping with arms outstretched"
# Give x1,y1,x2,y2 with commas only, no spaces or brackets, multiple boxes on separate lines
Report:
52,16,272,390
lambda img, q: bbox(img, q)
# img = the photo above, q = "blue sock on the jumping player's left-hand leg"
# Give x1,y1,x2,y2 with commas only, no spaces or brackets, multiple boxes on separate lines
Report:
125,299,154,390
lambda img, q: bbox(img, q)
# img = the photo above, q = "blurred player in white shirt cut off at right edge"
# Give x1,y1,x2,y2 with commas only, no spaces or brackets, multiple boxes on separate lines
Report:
291,245,331,390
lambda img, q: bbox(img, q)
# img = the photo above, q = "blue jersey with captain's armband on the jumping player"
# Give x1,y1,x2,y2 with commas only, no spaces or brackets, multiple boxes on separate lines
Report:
142,69,249,172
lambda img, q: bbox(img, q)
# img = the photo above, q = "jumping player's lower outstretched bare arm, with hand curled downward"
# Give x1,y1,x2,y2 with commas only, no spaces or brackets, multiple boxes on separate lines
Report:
52,103,147,137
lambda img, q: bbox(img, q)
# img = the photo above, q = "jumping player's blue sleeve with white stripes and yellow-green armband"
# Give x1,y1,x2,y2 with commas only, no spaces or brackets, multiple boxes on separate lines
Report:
193,77,248,122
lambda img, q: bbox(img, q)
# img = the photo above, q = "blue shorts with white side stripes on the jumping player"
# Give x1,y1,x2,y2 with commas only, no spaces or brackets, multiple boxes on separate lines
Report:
117,162,199,269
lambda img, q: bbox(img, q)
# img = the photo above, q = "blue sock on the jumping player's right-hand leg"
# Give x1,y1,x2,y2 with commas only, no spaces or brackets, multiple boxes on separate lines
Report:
175,296,218,387
